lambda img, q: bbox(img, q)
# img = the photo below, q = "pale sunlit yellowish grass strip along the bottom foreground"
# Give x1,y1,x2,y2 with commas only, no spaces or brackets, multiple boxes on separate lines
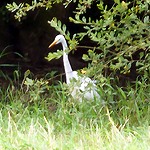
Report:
0,108,150,150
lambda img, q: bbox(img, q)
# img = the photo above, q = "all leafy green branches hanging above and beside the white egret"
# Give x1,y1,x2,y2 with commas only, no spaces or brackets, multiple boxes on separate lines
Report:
7,0,150,81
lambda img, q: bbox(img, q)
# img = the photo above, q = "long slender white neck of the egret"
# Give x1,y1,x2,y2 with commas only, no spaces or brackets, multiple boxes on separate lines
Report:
62,40,72,83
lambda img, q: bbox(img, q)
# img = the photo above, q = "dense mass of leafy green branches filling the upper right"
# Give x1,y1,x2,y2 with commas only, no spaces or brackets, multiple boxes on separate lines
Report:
74,1,150,78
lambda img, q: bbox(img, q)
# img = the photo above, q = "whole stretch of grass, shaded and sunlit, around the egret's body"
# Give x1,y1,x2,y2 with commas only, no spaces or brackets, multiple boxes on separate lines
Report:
0,77,150,150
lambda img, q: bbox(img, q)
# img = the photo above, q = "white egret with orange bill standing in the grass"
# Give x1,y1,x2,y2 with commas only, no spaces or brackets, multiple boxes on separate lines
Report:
49,35,100,101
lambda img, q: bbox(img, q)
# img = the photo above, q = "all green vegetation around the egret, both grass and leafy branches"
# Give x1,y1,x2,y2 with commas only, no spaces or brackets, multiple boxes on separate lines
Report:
0,0,150,150
